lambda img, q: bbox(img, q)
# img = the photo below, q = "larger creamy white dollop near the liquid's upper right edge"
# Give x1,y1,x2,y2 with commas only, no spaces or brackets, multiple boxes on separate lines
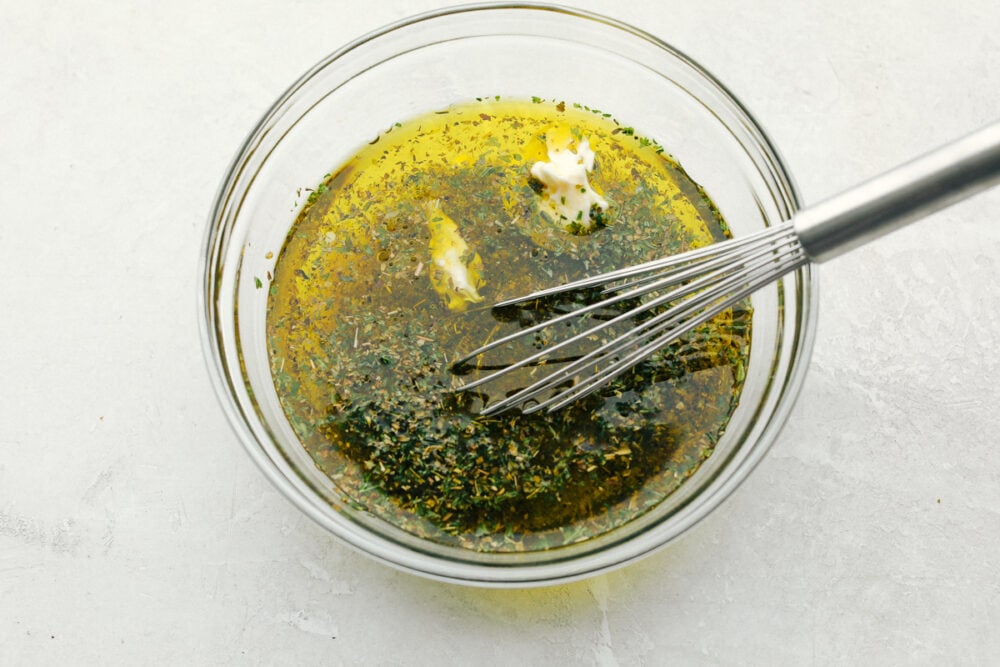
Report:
531,128,608,233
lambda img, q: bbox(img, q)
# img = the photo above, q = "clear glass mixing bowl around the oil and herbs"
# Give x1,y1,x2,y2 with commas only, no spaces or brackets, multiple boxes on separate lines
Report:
200,4,817,586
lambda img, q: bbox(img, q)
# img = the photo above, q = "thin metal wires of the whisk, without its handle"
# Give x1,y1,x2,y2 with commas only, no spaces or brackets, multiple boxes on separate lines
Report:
453,223,806,415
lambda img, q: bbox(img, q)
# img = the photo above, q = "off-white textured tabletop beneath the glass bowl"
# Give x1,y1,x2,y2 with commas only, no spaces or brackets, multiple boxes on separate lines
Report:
0,0,1000,665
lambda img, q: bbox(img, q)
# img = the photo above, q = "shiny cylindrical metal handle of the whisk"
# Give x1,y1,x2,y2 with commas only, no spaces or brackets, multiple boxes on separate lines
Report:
792,122,1000,262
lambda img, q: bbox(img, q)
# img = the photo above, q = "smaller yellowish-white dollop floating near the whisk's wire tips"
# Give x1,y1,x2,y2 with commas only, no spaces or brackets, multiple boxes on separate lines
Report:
427,199,483,311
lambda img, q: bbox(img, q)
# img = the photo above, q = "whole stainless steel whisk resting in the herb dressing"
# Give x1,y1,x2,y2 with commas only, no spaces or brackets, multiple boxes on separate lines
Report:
452,122,1000,415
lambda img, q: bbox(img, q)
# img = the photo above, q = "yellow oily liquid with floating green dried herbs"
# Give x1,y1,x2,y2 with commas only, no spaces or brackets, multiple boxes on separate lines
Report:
267,100,749,552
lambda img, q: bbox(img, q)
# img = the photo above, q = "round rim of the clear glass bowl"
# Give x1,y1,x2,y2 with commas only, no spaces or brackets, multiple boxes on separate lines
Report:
197,2,819,587
